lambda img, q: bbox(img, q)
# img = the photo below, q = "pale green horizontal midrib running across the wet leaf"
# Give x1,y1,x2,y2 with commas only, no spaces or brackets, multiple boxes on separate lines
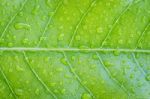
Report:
0,47,150,53
